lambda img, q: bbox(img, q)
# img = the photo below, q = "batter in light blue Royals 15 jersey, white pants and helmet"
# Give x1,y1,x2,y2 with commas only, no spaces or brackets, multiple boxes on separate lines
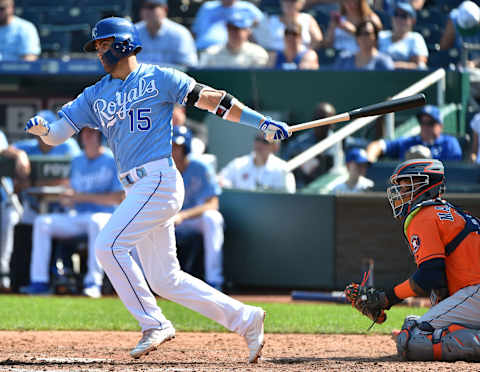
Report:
25,17,289,362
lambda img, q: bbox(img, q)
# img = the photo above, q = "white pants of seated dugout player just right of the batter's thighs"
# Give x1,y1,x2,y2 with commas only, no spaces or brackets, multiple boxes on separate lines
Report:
175,210,223,285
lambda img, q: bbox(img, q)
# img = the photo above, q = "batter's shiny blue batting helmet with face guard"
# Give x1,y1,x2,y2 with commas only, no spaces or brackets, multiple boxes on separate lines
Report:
83,17,142,64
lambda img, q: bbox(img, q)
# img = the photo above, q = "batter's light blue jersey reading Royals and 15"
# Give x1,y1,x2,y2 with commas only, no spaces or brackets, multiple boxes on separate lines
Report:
59,64,195,173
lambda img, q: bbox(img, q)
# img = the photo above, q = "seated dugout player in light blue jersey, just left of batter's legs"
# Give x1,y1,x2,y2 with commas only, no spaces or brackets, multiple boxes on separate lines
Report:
20,128,124,298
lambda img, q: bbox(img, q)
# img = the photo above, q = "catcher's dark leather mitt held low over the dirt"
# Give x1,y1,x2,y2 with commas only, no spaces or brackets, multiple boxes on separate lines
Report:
345,283,388,325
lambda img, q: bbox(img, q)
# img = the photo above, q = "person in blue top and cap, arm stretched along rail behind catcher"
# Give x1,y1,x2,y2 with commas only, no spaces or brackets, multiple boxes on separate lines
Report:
367,105,462,163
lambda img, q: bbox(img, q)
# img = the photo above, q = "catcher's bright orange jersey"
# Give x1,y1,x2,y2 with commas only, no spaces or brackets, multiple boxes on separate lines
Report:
405,205,480,295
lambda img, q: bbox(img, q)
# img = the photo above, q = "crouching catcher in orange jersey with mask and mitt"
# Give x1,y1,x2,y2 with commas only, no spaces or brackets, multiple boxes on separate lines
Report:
345,159,480,361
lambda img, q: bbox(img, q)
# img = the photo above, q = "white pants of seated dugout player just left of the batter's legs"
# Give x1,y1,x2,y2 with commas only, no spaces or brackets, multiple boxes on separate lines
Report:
30,212,111,286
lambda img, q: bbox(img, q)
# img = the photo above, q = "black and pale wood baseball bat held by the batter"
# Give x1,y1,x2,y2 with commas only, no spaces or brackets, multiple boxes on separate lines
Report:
288,93,425,133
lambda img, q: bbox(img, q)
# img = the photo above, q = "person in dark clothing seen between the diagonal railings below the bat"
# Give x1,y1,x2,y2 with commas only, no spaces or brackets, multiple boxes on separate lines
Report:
282,102,336,188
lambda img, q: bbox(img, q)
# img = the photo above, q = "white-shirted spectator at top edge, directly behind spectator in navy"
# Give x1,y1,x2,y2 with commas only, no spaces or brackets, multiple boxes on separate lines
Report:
253,0,323,51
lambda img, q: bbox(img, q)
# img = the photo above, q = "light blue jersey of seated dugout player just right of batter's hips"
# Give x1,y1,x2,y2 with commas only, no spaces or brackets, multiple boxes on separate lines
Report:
182,159,222,209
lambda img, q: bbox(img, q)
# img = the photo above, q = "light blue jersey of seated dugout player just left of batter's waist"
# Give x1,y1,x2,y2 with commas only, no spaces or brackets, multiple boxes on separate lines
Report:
70,152,123,213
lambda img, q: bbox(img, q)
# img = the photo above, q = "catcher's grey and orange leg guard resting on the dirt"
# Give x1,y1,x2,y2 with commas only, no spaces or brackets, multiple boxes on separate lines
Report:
397,322,480,361
